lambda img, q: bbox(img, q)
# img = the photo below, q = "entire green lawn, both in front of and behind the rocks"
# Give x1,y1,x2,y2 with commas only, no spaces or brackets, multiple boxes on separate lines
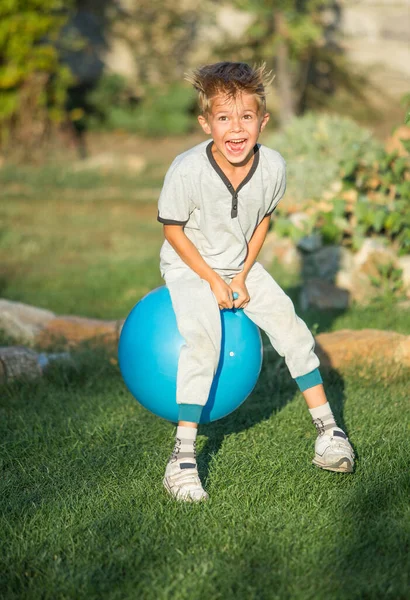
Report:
0,152,410,600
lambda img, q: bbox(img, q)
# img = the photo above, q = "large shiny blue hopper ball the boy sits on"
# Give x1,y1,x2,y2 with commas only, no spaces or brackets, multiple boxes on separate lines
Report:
118,286,262,423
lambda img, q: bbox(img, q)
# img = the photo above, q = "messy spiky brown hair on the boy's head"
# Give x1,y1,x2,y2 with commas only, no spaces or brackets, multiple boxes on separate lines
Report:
185,62,274,115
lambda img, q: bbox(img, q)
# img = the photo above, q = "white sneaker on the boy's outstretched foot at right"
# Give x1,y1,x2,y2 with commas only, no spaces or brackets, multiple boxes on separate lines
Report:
312,427,354,473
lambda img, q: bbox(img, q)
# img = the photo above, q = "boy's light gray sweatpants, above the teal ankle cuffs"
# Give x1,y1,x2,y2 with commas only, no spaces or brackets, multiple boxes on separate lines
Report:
164,263,319,406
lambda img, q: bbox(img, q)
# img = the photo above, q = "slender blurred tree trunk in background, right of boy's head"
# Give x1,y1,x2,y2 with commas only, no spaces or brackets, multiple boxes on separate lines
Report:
275,12,296,126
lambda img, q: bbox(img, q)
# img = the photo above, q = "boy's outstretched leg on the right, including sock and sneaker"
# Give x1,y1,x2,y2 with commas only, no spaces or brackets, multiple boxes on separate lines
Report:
244,263,354,472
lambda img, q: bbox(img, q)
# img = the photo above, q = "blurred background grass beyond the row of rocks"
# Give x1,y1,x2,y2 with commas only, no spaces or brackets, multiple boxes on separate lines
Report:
0,162,410,333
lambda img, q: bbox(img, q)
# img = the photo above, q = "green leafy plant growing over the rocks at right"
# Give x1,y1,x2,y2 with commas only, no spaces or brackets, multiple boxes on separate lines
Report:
277,125,410,256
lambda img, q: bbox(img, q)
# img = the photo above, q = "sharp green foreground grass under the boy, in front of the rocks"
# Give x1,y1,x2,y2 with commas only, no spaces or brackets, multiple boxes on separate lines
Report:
0,354,410,600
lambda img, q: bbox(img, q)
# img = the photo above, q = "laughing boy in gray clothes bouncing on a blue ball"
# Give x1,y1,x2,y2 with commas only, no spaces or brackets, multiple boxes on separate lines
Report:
158,62,354,502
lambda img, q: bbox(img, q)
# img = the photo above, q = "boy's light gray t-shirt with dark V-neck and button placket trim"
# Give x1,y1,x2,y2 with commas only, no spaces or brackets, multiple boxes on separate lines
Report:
158,140,286,277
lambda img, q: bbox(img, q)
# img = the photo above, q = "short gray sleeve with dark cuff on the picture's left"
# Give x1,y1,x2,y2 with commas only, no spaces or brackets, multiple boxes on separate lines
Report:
157,165,191,225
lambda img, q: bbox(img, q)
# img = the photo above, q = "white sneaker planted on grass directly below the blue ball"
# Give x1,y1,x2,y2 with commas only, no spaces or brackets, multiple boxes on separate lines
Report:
163,458,209,502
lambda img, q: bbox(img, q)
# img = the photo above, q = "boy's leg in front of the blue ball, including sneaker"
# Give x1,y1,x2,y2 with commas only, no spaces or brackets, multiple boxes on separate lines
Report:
164,269,221,501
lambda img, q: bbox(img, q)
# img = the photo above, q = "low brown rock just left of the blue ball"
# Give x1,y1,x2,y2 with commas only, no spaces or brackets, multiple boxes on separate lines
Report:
36,316,123,347
